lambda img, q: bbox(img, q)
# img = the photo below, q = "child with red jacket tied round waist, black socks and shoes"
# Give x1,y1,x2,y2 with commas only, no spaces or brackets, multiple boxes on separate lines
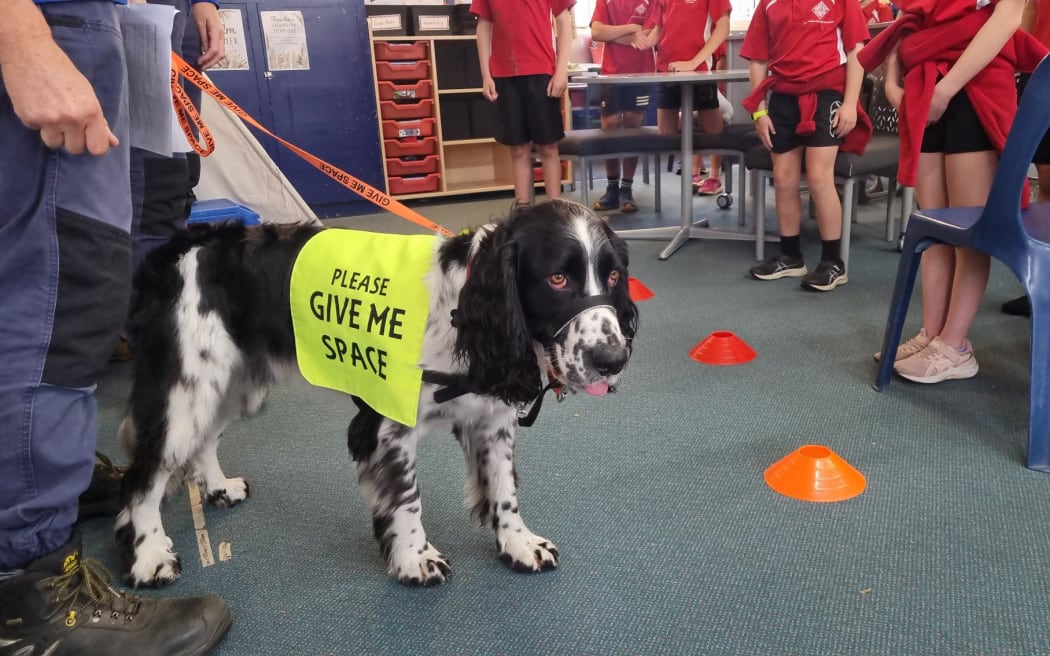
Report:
740,0,870,292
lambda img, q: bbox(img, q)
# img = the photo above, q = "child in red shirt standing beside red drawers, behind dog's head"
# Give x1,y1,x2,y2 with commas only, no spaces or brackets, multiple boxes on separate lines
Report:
470,0,575,205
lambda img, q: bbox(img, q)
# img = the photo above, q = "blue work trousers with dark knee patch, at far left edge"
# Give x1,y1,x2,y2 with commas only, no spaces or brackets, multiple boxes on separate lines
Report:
0,0,131,571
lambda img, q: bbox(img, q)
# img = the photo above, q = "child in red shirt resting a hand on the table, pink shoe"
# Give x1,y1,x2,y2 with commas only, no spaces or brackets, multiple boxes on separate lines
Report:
639,0,732,194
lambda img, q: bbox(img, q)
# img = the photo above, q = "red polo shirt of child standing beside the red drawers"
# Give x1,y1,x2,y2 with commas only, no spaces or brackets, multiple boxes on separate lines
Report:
470,0,576,78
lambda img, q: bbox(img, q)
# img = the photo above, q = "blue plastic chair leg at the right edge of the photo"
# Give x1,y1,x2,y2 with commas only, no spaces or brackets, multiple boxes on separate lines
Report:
1028,291,1050,472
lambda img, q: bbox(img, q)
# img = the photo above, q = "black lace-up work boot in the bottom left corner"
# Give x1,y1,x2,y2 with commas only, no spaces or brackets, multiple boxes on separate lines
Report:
0,534,231,656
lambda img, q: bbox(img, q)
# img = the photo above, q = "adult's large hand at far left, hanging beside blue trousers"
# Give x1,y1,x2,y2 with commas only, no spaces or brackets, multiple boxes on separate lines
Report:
0,39,120,155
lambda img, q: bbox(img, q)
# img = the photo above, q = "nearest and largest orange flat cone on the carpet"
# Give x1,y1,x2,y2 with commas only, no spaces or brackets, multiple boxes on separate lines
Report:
765,444,867,502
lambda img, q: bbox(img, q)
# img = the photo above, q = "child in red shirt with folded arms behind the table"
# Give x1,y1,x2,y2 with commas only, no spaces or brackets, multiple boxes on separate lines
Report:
591,0,656,212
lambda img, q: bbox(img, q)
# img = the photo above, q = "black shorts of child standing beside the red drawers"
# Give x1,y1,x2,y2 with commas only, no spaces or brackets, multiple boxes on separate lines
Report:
496,76,565,146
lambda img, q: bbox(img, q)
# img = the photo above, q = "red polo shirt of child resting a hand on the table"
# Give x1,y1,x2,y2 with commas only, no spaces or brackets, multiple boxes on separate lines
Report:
646,0,734,71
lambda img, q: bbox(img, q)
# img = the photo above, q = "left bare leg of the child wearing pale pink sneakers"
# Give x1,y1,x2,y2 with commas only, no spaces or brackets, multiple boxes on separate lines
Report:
916,152,956,337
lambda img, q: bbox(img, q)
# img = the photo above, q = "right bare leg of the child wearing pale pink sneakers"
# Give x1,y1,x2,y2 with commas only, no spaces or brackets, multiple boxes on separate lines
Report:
940,150,999,348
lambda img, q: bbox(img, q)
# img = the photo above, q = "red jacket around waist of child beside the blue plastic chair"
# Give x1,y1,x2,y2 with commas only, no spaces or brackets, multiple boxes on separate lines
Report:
858,0,1047,197
